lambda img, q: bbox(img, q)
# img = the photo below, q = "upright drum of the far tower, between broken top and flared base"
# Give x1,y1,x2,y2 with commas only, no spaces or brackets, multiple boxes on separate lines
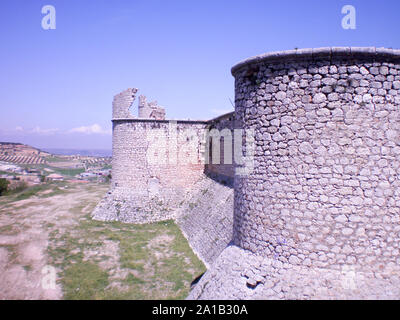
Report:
112,119,205,197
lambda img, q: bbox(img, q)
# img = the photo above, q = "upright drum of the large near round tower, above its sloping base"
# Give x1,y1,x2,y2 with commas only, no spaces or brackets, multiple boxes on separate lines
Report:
232,48,400,270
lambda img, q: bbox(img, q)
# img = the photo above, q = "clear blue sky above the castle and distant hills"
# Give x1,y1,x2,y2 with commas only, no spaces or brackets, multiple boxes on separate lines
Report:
0,0,400,148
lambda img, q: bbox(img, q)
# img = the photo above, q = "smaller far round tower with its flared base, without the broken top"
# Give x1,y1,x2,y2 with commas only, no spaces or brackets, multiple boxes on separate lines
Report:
93,119,206,223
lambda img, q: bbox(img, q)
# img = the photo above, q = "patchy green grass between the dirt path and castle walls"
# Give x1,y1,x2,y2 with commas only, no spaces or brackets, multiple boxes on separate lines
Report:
49,216,205,299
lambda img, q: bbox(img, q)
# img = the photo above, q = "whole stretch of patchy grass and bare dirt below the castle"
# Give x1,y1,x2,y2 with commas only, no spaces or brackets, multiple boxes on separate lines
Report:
0,182,205,299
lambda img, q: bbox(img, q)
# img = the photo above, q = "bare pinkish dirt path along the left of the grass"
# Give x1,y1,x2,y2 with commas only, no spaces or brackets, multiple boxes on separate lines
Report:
0,184,108,299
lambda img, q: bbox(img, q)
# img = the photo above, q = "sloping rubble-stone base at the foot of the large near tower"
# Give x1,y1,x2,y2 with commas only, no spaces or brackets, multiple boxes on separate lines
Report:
187,246,400,300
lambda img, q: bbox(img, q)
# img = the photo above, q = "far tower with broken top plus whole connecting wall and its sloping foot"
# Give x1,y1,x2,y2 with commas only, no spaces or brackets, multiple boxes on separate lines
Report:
92,88,238,266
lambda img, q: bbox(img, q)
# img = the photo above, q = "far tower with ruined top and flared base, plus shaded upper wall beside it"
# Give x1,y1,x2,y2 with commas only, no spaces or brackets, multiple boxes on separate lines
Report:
93,88,239,223
